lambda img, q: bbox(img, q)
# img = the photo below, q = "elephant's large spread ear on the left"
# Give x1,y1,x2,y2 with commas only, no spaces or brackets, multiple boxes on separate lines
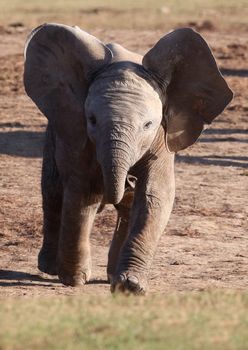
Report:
24,24,112,143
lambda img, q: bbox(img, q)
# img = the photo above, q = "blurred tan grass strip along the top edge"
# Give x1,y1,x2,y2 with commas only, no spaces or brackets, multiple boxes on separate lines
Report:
0,0,248,32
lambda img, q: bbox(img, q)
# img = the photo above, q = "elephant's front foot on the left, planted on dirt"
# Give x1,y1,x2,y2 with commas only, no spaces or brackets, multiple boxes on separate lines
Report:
58,259,91,287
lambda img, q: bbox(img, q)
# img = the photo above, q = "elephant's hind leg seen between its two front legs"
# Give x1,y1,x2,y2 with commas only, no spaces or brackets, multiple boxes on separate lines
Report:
107,191,133,282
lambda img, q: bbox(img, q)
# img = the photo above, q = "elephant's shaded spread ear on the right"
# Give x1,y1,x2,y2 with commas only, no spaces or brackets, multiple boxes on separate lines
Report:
143,28,233,152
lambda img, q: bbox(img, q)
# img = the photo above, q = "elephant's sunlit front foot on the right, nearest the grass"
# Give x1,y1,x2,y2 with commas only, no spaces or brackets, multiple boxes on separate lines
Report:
111,271,147,295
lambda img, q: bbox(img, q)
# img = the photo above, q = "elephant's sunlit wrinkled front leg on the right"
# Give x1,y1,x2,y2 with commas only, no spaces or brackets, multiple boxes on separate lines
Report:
111,153,175,294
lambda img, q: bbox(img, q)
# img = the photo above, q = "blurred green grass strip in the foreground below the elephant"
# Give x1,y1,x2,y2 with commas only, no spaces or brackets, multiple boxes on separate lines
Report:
0,290,248,350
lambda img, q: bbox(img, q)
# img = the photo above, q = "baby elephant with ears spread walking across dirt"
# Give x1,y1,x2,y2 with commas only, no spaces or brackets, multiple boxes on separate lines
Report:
24,24,232,294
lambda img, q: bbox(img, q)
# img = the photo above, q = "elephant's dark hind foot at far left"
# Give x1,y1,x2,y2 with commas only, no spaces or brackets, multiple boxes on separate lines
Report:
38,248,58,276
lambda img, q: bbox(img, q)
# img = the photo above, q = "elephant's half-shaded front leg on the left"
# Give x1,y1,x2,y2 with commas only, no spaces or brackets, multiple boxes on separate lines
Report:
58,188,101,286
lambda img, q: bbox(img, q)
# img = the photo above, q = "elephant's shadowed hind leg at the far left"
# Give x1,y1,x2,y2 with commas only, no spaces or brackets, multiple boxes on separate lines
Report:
38,126,63,275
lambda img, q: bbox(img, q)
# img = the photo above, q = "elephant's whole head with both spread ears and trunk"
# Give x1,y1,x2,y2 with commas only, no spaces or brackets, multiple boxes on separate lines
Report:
24,24,232,204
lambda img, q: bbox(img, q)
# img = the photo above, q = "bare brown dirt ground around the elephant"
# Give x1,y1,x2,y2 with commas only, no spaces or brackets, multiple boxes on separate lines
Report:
0,25,248,297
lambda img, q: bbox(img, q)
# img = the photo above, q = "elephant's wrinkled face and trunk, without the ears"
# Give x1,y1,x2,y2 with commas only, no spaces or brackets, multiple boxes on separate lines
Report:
85,62,162,204
